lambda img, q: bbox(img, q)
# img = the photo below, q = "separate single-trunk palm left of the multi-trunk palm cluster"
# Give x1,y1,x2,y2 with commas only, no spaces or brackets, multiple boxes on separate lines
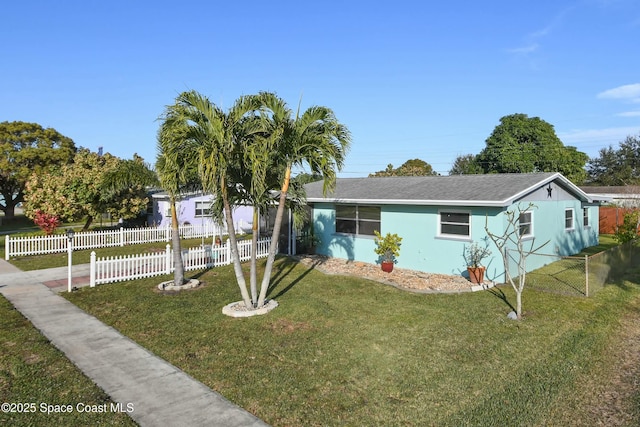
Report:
156,114,197,286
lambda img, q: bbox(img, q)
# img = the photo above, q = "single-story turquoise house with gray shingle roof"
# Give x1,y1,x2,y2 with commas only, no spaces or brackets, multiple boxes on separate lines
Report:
305,172,599,282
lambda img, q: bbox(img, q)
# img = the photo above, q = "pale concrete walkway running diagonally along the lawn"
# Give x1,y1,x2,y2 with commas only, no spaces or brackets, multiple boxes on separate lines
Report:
0,260,267,427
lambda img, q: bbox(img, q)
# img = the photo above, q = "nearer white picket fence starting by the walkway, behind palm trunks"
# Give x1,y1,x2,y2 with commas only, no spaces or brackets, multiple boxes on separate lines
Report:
89,239,271,287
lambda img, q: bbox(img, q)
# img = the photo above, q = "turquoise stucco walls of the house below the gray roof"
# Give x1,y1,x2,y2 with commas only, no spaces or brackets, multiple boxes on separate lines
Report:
313,188,598,282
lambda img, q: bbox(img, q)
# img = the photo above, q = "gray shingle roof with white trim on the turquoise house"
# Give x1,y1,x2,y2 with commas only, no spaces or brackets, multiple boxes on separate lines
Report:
305,172,588,206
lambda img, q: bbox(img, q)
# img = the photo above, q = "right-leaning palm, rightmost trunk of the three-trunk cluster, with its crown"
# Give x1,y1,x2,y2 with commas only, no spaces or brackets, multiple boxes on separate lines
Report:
257,93,351,307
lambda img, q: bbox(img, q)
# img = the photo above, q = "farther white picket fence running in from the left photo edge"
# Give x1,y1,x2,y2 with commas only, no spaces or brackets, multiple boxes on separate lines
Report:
4,223,227,261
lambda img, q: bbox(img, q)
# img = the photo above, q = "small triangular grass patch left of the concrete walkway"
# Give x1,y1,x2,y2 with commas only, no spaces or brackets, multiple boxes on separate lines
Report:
0,297,135,426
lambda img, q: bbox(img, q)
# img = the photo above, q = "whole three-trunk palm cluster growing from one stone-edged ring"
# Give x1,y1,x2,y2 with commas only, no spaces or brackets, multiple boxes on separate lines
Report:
159,91,350,308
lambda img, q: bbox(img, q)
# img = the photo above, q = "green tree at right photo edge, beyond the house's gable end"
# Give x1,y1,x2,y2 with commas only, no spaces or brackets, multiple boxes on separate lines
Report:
587,135,640,185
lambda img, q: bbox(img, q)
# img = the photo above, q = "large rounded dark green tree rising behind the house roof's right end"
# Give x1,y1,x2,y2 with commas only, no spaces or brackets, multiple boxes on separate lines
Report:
476,114,588,184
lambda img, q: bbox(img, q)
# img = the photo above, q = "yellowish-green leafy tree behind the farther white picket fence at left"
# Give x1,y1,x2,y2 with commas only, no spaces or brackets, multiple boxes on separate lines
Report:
24,149,149,230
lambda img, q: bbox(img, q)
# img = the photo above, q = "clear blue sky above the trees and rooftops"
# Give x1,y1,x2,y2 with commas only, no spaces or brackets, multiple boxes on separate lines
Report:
0,0,640,177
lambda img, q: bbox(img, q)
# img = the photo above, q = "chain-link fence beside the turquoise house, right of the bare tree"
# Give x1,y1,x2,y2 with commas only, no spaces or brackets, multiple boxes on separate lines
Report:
509,242,640,297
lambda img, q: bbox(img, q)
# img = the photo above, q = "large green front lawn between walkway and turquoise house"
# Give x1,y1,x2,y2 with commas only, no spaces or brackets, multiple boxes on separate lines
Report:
57,258,640,426
